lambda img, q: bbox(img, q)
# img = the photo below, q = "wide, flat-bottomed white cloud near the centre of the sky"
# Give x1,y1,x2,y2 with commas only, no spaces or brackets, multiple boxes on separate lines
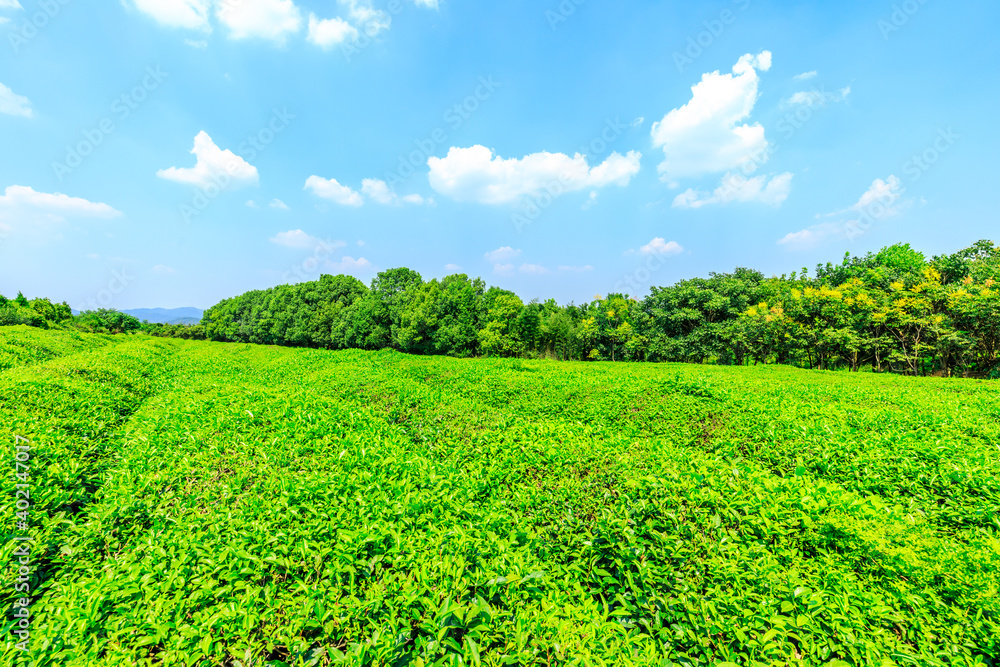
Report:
427,145,642,204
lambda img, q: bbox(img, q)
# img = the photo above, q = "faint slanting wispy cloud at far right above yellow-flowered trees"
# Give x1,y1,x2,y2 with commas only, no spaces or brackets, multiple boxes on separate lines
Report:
778,176,908,250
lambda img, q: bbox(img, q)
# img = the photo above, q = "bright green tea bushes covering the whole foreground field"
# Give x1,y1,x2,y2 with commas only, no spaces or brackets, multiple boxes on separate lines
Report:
0,327,1000,667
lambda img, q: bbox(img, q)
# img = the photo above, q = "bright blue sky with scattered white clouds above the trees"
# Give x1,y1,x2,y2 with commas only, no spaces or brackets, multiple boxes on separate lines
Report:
0,0,1000,308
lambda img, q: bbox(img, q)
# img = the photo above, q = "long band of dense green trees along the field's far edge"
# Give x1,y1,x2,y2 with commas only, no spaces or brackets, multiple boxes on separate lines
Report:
0,241,1000,378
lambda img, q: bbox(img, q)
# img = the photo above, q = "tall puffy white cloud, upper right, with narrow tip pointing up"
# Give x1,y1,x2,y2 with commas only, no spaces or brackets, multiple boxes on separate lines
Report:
652,51,771,185
